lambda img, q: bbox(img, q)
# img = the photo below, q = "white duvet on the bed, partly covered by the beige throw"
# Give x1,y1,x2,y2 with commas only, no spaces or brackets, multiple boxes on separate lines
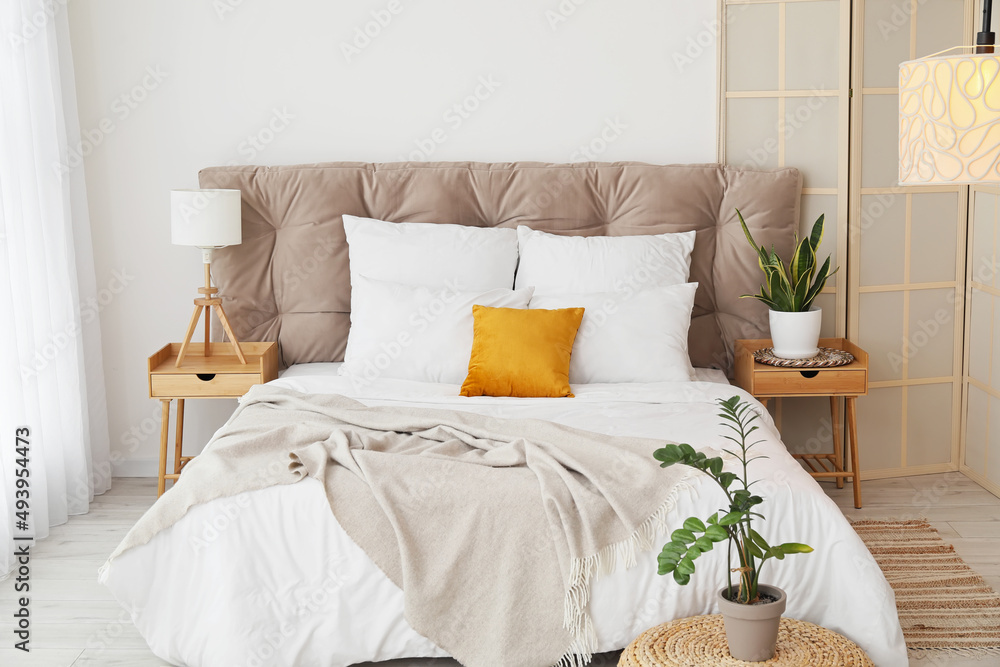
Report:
101,364,908,667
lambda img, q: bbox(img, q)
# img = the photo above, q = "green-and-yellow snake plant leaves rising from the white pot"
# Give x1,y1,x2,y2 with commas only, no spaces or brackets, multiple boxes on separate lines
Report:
736,209,837,313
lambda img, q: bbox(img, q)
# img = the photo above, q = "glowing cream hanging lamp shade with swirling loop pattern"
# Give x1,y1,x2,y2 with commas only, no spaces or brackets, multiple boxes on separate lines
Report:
899,54,1000,185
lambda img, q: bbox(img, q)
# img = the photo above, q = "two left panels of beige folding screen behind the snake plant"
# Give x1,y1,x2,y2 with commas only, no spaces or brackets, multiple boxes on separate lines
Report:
722,0,971,478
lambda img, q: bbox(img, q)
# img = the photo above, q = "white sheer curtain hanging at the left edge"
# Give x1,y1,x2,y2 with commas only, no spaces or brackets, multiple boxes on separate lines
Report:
0,0,111,578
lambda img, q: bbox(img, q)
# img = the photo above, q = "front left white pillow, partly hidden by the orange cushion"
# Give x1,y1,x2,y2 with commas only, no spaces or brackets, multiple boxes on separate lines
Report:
339,276,534,386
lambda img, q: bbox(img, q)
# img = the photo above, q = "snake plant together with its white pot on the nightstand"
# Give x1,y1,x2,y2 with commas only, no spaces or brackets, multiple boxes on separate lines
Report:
736,209,837,359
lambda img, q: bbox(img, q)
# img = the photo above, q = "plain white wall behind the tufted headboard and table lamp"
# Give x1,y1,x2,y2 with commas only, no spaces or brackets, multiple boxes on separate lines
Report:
69,0,716,475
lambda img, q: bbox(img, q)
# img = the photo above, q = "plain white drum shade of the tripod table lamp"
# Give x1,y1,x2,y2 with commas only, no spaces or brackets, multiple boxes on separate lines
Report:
170,190,243,248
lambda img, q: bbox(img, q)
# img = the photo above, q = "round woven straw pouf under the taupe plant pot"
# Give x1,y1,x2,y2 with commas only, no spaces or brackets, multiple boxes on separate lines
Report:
618,614,875,667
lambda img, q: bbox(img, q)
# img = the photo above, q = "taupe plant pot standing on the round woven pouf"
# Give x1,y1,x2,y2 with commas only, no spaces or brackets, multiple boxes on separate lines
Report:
716,585,787,662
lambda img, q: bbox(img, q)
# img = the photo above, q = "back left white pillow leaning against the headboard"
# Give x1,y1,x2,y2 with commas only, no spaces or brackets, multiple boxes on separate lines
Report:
344,215,517,290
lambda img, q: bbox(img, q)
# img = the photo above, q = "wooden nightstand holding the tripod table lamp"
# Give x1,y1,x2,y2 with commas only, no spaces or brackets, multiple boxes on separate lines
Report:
149,343,278,496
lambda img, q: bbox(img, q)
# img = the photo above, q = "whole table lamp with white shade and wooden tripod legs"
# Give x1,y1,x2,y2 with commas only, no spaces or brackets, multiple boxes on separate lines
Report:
170,190,247,368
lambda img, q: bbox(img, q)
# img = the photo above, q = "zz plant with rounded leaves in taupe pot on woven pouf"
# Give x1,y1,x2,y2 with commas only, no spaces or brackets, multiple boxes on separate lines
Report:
653,396,812,662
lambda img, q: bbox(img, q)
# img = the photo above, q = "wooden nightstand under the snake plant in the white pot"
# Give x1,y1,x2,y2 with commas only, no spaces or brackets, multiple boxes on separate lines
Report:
735,338,868,509
